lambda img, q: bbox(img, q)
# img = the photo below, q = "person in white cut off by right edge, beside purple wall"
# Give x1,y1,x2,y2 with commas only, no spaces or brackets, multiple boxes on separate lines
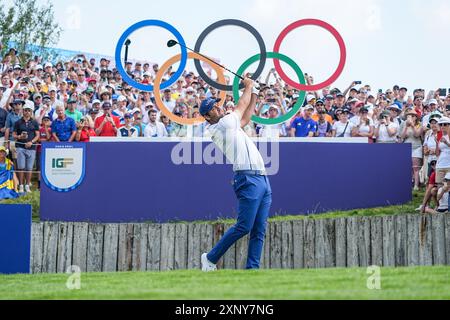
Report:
436,117,450,188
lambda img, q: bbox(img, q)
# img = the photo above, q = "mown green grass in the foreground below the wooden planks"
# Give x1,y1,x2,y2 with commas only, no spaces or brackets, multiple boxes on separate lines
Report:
0,267,450,300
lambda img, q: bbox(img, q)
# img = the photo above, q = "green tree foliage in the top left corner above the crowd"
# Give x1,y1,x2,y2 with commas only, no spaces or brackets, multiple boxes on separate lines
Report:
0,0,62,60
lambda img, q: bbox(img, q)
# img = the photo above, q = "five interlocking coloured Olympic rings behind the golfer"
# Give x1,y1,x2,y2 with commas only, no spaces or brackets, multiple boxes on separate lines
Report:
115,19,347,125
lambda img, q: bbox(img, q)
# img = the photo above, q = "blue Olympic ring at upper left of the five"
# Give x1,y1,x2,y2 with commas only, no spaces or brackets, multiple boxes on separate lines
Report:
115,20,188,92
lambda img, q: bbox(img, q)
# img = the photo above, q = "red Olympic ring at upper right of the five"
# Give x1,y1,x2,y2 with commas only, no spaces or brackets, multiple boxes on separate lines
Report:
273,19,347,91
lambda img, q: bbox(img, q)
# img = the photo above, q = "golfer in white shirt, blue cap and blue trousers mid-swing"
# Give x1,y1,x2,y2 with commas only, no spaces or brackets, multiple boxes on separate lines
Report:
200,75,272,272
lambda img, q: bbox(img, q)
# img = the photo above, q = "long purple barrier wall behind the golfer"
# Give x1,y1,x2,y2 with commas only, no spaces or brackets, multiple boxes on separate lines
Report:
41,142,412,223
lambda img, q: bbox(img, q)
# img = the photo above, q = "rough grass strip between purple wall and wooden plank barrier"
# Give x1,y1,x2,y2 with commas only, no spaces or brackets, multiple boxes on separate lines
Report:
0,191,424,223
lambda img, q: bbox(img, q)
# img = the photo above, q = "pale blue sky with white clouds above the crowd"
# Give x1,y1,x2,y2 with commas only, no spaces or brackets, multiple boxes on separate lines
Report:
6,0,450,91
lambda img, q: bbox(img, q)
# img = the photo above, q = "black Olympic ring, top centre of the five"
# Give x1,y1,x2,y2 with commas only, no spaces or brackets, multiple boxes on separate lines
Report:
194,19,267,91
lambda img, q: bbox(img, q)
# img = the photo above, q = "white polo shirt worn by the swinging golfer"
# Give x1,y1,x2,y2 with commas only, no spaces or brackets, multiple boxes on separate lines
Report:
208,111,265,171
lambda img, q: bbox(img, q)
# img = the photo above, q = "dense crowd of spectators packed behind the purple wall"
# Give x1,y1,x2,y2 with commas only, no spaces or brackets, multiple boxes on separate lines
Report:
0,49,450,210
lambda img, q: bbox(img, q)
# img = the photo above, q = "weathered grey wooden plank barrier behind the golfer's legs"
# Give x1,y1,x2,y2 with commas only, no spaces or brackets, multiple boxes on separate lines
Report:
30,214,450,273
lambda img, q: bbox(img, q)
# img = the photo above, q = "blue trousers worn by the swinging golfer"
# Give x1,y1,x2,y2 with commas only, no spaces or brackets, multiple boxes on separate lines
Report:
207,174,272,269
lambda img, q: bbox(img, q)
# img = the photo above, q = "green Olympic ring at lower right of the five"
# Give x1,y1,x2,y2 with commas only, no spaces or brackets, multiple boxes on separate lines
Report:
233,52,306,125
